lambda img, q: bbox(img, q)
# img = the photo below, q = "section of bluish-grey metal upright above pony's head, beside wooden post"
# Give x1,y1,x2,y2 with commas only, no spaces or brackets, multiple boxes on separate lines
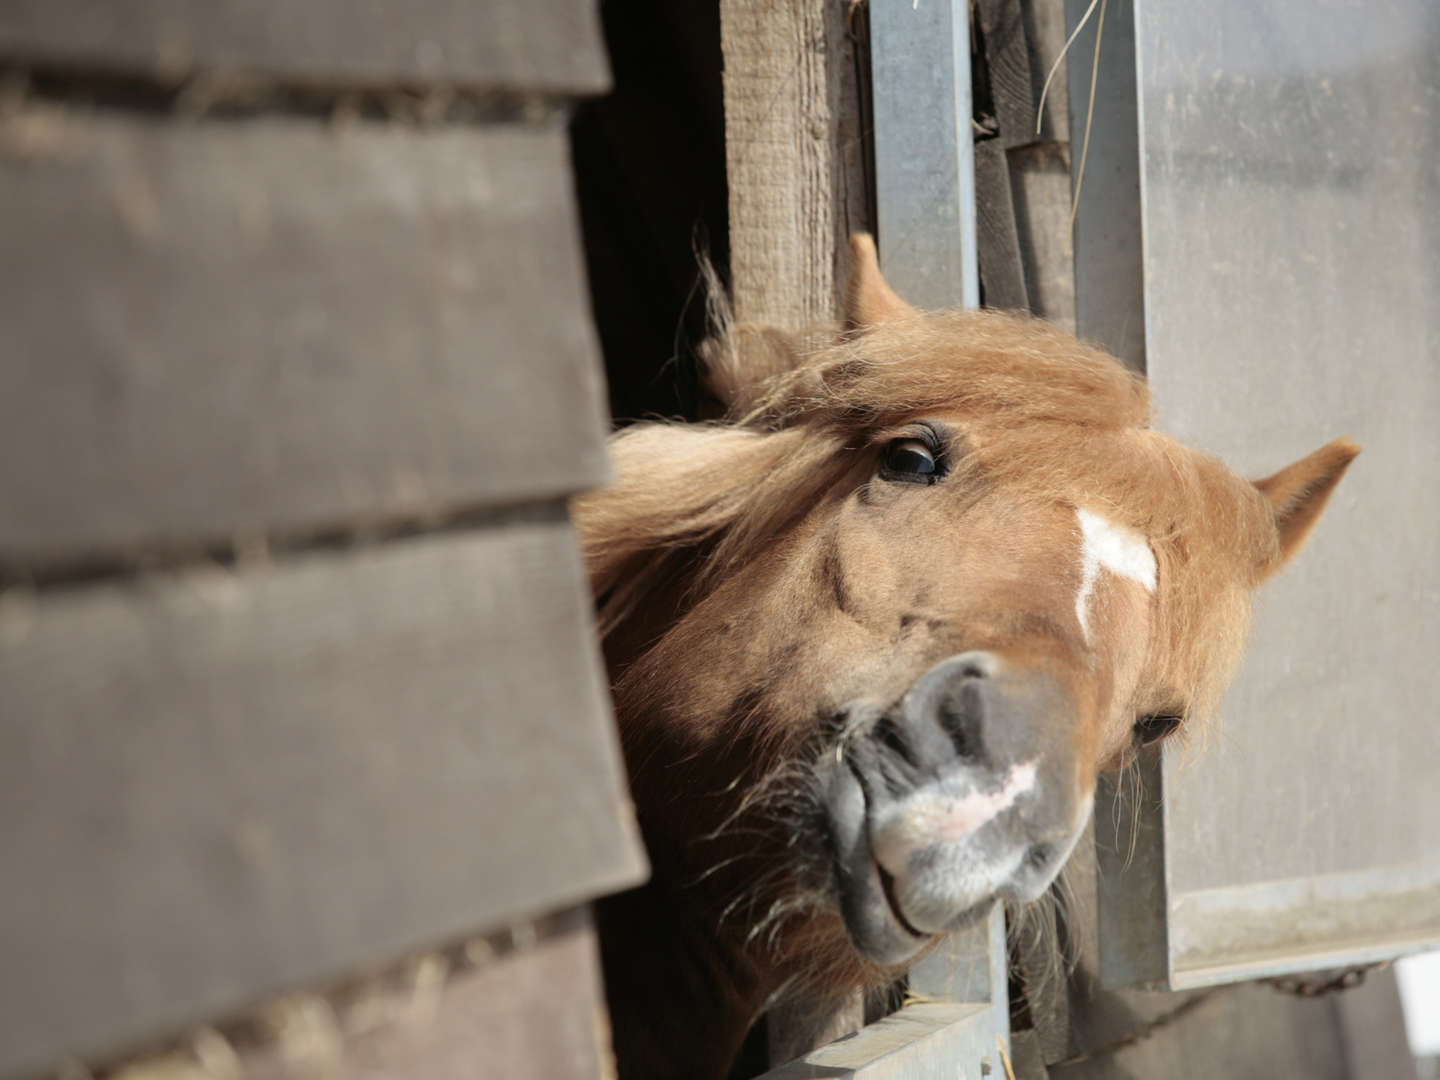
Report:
870,0,979,308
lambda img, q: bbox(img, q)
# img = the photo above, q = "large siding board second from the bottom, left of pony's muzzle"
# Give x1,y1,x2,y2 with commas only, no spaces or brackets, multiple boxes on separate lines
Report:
0,507,645,1074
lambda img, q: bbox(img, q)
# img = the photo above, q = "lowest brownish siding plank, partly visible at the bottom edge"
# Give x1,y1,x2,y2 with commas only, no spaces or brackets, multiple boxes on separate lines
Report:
94,907,613,1080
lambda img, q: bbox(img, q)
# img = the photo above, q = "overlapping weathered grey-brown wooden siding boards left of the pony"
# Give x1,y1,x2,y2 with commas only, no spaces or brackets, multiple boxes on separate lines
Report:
0,0,645,1077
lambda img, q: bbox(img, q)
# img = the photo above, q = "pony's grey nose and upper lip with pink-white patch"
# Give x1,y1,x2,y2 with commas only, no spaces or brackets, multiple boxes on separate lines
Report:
850,652,1084,933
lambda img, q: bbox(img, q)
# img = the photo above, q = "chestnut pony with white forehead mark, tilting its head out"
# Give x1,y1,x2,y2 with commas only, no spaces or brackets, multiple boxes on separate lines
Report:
577,236,1358,1077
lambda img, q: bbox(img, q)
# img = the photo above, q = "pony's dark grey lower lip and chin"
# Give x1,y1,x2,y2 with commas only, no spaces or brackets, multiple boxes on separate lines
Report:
825,765,935,966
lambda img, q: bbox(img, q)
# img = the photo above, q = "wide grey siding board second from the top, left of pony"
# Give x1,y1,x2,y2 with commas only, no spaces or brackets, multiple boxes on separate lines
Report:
0,109,606,564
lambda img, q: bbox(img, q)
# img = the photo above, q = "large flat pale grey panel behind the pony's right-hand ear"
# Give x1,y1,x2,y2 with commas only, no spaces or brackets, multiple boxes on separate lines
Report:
1077,0,1440,988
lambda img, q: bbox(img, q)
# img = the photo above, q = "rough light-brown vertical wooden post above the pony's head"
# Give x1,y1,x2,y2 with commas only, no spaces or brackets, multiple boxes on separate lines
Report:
720,0,874,328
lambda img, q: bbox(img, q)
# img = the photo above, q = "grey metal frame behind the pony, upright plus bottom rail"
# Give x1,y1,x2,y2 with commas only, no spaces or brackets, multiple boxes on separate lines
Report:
762,0,1009,1080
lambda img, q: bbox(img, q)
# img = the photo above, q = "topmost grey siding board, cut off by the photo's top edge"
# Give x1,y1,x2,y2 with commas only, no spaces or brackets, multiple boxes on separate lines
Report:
0,0,609,94
